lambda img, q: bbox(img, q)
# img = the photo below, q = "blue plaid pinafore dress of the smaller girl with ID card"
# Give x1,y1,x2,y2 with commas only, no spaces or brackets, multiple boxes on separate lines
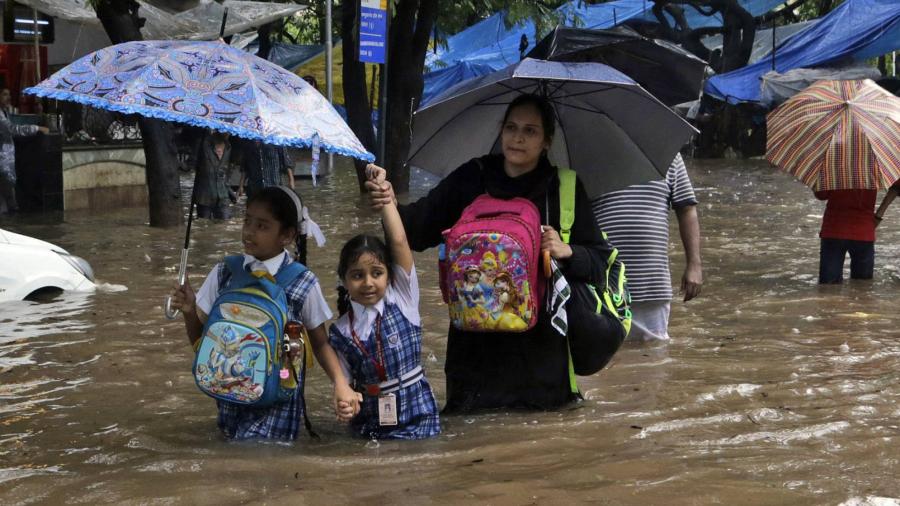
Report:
329,300,441,439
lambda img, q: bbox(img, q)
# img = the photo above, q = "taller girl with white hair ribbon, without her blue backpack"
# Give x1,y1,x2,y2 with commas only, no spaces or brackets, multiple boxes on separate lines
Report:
172,186,359,440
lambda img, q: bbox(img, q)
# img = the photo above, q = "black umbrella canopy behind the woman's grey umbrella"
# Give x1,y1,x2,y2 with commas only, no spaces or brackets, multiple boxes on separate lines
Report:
527,26,706,106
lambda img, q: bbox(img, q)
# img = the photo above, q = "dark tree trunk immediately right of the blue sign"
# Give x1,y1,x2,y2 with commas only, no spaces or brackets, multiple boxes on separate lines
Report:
382,0,438,193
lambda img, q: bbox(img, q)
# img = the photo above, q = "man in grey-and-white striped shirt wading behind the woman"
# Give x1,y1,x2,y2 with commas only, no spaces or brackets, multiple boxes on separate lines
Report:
591,154,703,341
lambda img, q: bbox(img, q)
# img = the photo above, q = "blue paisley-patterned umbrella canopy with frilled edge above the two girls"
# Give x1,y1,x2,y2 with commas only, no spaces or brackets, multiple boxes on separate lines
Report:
25,41,374,161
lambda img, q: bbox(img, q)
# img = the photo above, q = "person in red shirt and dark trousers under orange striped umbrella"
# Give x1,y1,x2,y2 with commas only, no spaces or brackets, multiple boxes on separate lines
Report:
815,190,878,283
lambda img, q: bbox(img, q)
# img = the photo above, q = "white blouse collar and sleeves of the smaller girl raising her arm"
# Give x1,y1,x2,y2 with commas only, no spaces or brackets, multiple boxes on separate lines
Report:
334,265,422,341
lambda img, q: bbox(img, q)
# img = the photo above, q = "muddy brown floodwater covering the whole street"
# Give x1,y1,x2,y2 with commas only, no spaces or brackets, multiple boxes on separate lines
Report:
0,160,900,505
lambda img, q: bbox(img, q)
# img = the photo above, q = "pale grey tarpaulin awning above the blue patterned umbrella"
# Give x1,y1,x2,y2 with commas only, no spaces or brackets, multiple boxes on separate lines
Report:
19,0,306,40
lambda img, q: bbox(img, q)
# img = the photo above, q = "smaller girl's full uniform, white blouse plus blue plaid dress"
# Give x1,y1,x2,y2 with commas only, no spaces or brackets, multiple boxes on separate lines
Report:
329,265,441,439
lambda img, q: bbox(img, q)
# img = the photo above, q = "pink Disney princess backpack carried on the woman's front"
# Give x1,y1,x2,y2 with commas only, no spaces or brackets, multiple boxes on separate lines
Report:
439,194,545,332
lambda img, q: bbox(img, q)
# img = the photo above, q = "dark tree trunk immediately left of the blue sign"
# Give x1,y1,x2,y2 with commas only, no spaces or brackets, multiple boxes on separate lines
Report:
341,3,376,192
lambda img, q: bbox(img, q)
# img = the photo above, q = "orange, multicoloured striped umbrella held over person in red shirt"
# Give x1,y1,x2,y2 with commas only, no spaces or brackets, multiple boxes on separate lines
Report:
766,79,900,190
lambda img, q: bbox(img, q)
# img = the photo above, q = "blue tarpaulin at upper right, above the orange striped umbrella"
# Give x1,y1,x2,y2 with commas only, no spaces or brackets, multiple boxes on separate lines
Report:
705,0,900,103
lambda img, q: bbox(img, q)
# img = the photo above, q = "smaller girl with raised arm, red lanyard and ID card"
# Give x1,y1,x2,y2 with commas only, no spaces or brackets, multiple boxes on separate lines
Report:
329,165,441,439
